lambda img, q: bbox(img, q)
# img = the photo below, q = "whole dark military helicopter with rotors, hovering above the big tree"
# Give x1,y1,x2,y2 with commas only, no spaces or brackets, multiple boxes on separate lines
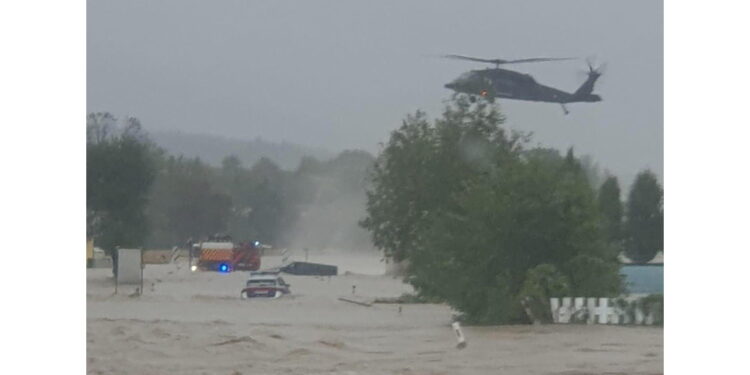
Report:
443,55,602,115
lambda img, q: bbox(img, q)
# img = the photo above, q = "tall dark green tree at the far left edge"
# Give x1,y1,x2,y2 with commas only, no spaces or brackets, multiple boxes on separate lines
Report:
86,113,155,254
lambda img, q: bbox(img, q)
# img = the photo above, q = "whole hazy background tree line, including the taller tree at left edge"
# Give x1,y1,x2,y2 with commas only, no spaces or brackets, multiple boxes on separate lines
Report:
87,113,374,253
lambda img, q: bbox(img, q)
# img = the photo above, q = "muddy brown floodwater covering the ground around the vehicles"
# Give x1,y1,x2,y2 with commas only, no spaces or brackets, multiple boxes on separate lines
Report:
86,252,663,375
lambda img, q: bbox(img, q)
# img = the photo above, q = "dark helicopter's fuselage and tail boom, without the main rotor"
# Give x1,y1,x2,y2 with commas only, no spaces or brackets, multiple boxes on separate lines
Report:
445,68,601,104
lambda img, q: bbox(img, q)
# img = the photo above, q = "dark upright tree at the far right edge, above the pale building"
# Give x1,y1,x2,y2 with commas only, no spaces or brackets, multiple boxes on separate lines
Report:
625,170,664,263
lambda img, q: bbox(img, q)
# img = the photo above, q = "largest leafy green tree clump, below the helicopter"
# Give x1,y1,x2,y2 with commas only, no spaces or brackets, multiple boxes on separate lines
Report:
362,95,620,324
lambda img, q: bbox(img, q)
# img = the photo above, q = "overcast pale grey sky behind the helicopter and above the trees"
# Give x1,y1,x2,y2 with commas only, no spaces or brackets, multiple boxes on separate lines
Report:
87,0,663,186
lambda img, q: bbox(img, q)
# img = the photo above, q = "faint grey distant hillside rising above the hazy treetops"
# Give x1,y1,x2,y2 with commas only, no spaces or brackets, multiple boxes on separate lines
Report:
149,131,335,170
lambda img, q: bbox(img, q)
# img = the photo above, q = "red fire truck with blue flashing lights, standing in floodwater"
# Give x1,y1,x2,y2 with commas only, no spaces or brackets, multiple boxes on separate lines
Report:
190,236,261,273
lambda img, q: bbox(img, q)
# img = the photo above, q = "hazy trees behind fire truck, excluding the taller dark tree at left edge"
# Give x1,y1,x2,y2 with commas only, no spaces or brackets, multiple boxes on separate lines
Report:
139,137,373,247
